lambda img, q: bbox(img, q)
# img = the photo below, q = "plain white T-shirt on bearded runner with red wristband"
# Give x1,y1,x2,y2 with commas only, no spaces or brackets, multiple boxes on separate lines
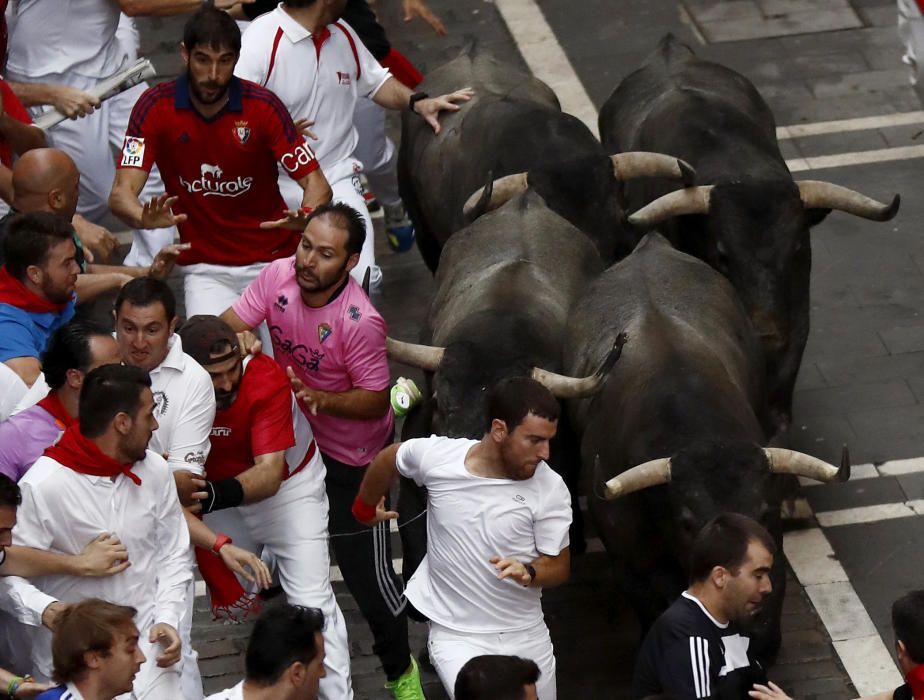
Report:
397,435,571,634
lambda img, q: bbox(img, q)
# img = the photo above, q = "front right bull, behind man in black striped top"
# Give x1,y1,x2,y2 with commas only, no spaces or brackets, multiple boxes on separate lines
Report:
564,233,849,658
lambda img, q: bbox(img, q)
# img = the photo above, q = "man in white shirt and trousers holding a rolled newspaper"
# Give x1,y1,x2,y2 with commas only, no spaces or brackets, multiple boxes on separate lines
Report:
6,0,239,267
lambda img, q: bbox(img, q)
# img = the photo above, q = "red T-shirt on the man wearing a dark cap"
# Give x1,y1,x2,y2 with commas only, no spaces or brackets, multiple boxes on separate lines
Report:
205,355,295,480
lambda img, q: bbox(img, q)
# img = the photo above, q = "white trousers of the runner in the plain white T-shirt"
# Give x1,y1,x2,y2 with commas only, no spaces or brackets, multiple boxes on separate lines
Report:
427,620,556,700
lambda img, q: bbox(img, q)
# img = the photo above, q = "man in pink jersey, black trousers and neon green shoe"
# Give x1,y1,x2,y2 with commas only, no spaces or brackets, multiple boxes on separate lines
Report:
221,203,424,700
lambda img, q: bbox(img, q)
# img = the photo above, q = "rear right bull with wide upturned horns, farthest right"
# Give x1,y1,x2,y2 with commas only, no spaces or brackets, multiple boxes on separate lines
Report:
600,35,899,433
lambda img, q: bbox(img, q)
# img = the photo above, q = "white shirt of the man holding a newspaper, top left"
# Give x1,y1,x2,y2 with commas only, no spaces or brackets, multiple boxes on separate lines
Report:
6,0,126,82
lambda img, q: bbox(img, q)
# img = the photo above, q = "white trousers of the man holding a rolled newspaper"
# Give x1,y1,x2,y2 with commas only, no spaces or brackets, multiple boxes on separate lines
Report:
8,74,176,267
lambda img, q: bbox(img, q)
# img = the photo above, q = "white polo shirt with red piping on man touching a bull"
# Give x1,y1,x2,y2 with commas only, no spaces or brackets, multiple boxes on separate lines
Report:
234,5,391,182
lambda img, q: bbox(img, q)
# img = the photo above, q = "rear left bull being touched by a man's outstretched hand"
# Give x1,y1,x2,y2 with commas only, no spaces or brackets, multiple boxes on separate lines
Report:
398,46,693,271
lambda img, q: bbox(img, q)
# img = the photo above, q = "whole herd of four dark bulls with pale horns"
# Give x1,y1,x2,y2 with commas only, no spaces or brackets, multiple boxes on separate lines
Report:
389,35,899,657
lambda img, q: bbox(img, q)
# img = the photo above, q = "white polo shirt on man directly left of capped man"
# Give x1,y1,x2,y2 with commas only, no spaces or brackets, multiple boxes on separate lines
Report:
148,333,215,474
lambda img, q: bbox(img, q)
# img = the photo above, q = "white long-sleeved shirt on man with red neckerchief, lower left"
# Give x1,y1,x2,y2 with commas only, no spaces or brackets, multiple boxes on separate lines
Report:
0,450,192,676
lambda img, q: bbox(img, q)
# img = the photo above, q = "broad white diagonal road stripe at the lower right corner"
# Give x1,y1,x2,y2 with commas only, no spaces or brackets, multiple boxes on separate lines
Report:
783,528,902,695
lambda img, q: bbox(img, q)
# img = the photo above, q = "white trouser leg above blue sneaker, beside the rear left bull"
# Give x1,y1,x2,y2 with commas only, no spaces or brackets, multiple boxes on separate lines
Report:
353,97,401,207
